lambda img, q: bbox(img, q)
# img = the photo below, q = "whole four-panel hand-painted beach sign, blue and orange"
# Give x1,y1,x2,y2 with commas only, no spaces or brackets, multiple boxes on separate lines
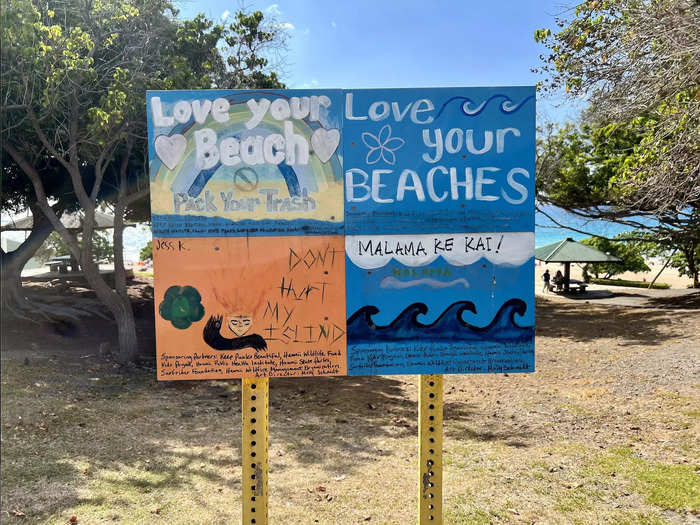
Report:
147,87,535,379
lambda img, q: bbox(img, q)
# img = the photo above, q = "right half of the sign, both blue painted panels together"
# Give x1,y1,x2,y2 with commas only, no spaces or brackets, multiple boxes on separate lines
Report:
343,87,535,375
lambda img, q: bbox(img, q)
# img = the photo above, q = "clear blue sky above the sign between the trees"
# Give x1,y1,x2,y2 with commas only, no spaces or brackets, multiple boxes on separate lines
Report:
176,0,578,121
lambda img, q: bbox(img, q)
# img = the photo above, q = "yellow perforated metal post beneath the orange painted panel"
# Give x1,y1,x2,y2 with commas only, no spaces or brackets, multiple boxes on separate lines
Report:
241,378,270,525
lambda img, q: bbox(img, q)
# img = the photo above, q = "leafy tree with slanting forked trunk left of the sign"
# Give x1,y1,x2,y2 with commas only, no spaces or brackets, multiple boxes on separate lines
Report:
0,0,288,363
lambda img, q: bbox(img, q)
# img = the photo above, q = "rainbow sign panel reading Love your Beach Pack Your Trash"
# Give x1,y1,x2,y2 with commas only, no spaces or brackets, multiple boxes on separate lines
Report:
147,90,344,237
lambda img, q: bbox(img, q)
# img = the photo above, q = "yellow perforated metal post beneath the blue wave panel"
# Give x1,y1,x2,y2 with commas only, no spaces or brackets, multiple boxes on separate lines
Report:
418,374,442,525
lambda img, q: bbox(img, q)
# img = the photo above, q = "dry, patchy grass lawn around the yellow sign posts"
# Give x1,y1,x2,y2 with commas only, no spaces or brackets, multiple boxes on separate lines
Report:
1,300,700,525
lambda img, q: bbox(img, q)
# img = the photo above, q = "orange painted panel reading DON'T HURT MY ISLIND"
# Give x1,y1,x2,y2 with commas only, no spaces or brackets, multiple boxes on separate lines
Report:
153,236,347,380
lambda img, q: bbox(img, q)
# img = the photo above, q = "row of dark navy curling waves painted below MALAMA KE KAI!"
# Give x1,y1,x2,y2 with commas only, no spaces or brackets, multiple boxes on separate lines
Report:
347,299,535,344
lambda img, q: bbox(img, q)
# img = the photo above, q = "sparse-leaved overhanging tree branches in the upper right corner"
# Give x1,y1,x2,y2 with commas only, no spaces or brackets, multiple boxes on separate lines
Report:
535,0,700,215
